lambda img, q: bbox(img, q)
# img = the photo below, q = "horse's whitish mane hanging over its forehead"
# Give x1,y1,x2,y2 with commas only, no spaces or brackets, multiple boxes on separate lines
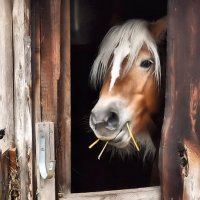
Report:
90,20,161,89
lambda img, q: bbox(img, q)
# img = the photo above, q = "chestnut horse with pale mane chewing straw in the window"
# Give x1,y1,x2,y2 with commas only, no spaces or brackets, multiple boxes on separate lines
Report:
89,17,167,178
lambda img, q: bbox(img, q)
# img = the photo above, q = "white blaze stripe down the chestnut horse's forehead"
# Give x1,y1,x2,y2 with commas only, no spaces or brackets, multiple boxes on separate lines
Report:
109,42,130,92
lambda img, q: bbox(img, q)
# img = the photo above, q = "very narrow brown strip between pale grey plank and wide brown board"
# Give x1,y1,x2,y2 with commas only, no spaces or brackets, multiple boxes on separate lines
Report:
31,1,41,200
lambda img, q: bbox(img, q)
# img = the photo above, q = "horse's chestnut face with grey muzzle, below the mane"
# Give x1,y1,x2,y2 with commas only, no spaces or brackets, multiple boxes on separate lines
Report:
90,18,166,151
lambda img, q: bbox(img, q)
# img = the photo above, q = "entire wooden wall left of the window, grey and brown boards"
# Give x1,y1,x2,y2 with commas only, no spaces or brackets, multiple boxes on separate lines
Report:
0,0,70,200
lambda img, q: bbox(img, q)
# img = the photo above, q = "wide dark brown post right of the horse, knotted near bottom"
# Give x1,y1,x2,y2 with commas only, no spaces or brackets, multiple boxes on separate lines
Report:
161,0,200,199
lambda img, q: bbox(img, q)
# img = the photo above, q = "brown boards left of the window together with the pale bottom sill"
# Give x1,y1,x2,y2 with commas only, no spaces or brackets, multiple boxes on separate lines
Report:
32,0,161,200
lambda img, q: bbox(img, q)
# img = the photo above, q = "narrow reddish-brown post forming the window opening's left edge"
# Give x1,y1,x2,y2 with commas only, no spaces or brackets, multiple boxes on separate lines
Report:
56,0,71,193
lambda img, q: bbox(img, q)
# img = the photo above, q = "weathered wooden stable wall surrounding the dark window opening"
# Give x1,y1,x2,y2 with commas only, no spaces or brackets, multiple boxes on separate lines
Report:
0,0,200,200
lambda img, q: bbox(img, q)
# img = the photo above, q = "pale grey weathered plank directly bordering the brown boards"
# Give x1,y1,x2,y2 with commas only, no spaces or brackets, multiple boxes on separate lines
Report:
13,0,33,200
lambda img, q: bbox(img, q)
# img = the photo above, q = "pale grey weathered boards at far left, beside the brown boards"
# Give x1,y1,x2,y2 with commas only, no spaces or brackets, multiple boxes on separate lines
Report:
0,0,33,199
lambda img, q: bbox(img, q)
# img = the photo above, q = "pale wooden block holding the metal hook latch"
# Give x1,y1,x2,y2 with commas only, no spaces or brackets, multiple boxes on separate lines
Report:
36,122,56,179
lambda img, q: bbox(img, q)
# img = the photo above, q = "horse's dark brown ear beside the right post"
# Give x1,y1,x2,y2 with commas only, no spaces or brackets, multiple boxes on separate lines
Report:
149,17,167,43
